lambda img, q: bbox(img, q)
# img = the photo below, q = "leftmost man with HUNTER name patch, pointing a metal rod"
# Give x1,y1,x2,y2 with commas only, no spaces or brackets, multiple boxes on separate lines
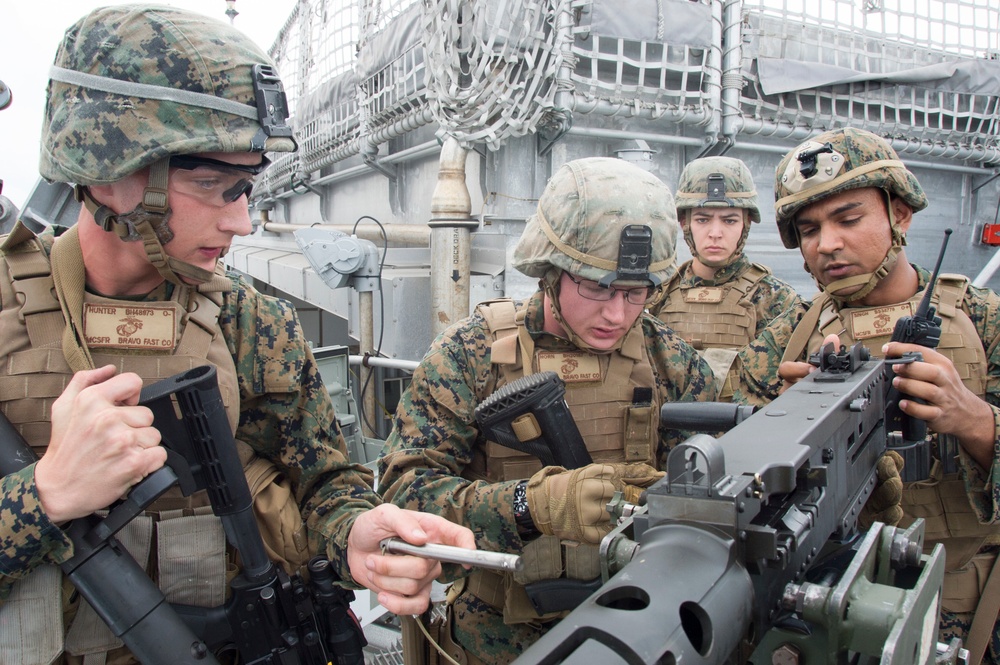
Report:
0,5,473,665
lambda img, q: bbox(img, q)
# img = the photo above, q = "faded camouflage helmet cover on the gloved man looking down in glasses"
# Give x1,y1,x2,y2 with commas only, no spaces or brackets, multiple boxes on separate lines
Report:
513,157,678,283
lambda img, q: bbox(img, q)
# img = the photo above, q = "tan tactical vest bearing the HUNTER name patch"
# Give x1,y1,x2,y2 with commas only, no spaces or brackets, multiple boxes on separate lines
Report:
0,225,240,663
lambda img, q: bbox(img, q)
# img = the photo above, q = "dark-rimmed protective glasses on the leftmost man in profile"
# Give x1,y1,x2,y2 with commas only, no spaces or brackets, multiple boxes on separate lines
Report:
170,155,270,208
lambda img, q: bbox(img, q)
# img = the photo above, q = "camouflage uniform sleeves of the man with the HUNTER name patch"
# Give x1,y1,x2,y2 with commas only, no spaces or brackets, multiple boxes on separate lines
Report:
0,229,381,663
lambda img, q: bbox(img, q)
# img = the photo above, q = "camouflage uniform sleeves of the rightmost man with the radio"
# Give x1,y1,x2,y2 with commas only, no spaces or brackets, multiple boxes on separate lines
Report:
733,266,1000,664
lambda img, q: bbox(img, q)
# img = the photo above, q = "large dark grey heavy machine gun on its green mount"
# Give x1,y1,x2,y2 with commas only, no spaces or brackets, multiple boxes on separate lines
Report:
516,345,944,665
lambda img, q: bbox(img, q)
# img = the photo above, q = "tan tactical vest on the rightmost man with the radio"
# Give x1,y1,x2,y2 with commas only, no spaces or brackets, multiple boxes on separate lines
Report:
782,275,1000,611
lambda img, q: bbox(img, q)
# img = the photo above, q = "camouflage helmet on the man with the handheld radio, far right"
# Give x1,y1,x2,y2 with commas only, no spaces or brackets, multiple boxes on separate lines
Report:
774,127,927,249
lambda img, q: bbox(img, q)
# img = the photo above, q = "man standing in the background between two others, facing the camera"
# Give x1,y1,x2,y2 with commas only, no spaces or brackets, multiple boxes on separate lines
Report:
650,157,800,400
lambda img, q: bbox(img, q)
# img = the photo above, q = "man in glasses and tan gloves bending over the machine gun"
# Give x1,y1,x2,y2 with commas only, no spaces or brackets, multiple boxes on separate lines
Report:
379,158,715,663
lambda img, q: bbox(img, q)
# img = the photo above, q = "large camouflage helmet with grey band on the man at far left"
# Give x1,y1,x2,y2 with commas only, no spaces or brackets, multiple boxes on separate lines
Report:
40,4,296,185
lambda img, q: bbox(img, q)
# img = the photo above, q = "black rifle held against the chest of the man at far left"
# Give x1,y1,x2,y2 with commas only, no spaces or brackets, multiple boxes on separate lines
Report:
0,366,365,665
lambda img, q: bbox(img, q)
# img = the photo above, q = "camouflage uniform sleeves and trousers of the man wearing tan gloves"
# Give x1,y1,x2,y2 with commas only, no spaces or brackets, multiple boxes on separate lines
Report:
379,292,715,663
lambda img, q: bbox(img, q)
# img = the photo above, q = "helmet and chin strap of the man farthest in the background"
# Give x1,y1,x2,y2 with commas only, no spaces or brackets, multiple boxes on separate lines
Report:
675,157,760,268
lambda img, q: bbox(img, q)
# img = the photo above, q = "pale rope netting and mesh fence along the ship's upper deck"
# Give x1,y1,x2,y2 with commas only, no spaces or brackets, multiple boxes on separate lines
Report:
263,0,1000,195
